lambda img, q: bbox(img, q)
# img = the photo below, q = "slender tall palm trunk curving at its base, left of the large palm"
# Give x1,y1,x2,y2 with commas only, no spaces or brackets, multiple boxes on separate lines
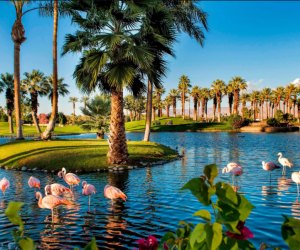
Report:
42,0,58,140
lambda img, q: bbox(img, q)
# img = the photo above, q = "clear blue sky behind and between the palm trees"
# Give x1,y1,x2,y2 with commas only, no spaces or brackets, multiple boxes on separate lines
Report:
0,1,300,114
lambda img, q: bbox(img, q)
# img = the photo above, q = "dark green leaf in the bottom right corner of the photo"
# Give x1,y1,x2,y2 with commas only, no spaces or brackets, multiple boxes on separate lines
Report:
281,216,300,250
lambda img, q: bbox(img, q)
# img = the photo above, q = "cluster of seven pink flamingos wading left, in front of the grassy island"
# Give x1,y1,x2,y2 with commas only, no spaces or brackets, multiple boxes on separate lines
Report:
0,168,127,219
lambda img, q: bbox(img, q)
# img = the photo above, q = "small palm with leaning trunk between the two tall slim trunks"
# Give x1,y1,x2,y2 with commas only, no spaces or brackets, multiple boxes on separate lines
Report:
22,70,47,134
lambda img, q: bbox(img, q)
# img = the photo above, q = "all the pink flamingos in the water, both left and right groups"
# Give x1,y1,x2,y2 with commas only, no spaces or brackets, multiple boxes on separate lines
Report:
0,149,300,218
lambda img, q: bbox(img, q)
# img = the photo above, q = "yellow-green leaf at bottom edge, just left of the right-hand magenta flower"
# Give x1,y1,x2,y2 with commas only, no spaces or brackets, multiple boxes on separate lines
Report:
205,222,223,250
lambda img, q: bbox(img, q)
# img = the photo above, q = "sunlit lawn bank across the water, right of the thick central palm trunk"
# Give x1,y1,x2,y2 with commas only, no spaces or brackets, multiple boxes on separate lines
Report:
126,117,232,132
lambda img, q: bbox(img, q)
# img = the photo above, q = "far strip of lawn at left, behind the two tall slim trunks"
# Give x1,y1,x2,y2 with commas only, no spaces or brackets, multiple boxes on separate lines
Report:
0,122,86,136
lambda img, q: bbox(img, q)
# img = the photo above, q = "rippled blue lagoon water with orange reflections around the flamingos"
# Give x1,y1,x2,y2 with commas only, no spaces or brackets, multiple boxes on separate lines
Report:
0,132,300,249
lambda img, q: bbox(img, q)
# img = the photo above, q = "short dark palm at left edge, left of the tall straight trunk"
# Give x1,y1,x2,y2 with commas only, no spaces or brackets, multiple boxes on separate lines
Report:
0,73,14,134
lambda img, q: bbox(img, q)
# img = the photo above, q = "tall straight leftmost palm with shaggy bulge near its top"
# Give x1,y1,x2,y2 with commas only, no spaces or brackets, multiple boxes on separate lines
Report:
11,0,29,140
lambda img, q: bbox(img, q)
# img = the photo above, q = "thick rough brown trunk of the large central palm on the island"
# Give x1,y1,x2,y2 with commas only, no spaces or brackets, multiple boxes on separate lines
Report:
107,90,128,164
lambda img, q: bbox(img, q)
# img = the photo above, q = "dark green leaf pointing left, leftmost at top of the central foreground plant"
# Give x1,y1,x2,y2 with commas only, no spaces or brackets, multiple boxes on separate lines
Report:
181,178,215,206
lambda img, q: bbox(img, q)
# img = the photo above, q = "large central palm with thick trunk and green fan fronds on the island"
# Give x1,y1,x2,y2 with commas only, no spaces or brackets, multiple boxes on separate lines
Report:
63,0,155,164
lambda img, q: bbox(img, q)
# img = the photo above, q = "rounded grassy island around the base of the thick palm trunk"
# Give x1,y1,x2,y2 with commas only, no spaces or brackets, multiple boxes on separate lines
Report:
0,140,177,171
